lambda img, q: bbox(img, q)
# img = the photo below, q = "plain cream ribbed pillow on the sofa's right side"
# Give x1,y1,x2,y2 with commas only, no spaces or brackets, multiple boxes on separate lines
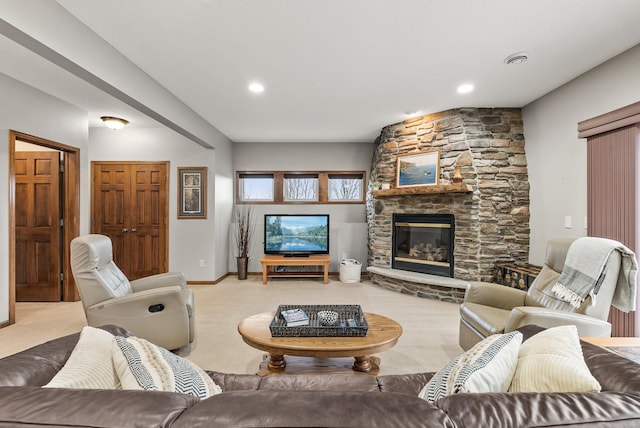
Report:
509,325,601,392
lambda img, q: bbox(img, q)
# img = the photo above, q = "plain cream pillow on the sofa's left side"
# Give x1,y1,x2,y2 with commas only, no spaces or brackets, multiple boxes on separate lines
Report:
44,327,120,389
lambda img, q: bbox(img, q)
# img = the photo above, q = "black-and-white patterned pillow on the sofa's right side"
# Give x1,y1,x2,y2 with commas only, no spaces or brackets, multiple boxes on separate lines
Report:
418,331,522,403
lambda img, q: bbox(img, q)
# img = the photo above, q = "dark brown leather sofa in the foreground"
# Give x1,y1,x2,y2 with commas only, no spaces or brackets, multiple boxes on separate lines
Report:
0,327,640,428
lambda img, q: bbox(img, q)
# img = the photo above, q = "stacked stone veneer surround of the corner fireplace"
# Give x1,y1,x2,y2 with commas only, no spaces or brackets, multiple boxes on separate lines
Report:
367,108,529,281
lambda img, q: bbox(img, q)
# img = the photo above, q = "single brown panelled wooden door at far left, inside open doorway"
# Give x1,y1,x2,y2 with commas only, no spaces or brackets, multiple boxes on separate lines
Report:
14,151,62,302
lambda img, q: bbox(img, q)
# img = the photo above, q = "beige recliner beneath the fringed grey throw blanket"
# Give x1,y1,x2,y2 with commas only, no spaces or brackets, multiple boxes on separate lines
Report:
459,238,622,350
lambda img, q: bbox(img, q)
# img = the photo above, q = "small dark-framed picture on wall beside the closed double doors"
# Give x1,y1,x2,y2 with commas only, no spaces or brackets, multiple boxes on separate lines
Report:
178,166,207,219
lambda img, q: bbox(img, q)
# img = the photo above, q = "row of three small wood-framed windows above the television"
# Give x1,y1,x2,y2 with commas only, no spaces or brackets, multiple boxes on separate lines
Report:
236,171,366,204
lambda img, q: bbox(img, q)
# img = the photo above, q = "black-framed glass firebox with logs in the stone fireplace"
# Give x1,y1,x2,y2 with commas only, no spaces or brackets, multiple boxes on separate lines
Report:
391,214,455,278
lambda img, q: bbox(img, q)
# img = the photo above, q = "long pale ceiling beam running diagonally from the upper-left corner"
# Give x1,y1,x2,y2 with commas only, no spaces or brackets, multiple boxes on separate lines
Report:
2,0,220,148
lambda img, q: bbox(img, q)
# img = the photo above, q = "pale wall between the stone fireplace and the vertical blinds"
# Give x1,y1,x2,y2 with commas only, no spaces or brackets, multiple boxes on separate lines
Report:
523,45,640,265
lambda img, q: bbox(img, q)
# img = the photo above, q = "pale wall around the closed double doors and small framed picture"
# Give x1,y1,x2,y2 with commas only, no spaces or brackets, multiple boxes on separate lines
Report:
84,127,233,281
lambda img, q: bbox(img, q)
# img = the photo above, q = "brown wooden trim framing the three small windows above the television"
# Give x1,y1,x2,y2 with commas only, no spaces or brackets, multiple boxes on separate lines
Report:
235,170,367,205
